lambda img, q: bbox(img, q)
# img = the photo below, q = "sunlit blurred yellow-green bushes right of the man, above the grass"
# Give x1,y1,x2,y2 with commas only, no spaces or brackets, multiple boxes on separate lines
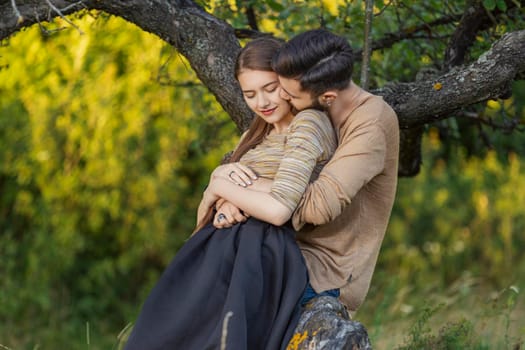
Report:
380,130,525,286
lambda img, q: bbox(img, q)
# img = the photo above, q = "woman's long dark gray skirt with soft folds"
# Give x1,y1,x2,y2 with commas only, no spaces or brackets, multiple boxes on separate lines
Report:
125,218,308,350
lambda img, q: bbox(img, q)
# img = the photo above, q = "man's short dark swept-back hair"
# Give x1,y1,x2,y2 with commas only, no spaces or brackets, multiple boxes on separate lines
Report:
272,29,354,98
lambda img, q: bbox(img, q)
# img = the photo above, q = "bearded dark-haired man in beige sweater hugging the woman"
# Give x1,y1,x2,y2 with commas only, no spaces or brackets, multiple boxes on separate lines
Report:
272,30,399,311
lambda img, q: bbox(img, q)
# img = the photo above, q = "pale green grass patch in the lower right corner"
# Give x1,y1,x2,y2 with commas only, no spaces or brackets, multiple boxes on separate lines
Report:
360,278,525,350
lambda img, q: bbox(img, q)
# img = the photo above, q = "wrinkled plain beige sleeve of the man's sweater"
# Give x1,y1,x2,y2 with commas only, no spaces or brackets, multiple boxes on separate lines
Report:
292,115,387,230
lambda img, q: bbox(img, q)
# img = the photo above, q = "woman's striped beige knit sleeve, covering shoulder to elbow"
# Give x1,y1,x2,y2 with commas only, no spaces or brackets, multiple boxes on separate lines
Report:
270,110,336,211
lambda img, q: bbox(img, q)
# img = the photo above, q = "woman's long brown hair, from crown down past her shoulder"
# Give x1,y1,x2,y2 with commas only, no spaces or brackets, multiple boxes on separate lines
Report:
193,36,283,233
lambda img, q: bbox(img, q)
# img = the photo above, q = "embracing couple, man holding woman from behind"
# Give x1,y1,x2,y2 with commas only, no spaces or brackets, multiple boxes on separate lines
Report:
125,30,399,350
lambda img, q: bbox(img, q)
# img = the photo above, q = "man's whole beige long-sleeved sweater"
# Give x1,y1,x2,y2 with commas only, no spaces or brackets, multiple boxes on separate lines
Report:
292,84,399,311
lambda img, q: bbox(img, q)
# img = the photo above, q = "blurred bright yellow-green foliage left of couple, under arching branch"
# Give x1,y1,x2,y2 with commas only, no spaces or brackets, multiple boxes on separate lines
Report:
0,15,236,348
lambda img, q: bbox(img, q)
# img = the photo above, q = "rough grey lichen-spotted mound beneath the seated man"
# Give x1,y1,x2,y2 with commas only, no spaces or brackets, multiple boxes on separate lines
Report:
287,296,372,350
